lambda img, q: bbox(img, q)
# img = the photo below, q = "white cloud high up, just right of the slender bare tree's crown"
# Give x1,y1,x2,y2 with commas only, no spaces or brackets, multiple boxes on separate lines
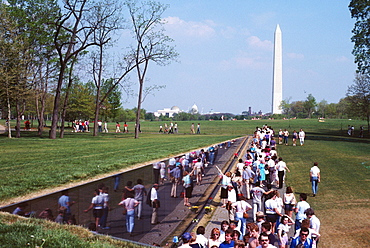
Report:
164,16,216,38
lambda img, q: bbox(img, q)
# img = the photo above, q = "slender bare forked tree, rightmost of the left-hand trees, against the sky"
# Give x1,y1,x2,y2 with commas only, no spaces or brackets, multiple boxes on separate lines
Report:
126,0,178,139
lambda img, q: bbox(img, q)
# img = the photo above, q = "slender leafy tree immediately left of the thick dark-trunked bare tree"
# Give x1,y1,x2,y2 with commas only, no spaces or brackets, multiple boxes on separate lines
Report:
6,0,59,135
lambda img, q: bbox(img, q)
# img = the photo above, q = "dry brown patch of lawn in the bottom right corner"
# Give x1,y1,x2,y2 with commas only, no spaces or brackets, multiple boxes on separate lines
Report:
317,206,370,248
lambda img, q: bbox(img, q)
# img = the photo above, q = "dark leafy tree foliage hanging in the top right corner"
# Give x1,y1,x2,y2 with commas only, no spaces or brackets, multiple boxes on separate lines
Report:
348,0,370,74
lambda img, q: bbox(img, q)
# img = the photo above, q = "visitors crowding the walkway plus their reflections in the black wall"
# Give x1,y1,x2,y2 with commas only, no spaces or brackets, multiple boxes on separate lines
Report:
9,125,321,248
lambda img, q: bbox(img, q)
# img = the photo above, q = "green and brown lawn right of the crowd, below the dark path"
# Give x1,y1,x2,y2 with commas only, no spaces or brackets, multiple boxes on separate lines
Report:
278,133,370,247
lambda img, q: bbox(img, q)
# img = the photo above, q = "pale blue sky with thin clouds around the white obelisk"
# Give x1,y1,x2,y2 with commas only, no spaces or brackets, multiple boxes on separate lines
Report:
123,0,356,114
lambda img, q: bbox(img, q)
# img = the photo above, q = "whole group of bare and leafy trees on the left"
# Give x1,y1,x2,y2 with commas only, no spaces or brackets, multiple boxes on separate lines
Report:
0,0,178,139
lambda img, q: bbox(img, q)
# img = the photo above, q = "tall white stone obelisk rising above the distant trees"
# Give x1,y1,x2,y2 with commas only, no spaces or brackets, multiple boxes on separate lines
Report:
272,24,283,114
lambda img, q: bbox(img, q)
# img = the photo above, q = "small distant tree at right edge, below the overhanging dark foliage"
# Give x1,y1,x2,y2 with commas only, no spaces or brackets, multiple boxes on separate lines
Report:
347,74,370,131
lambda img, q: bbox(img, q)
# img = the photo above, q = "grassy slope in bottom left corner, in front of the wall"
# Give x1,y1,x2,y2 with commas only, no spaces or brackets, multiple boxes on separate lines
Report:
0,213,149,248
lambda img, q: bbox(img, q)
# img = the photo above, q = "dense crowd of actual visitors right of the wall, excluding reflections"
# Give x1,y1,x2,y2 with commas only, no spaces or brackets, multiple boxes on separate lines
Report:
176,126,320,248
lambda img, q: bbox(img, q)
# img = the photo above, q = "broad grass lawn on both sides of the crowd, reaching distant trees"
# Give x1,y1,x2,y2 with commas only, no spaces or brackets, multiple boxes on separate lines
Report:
0,117,370,247
